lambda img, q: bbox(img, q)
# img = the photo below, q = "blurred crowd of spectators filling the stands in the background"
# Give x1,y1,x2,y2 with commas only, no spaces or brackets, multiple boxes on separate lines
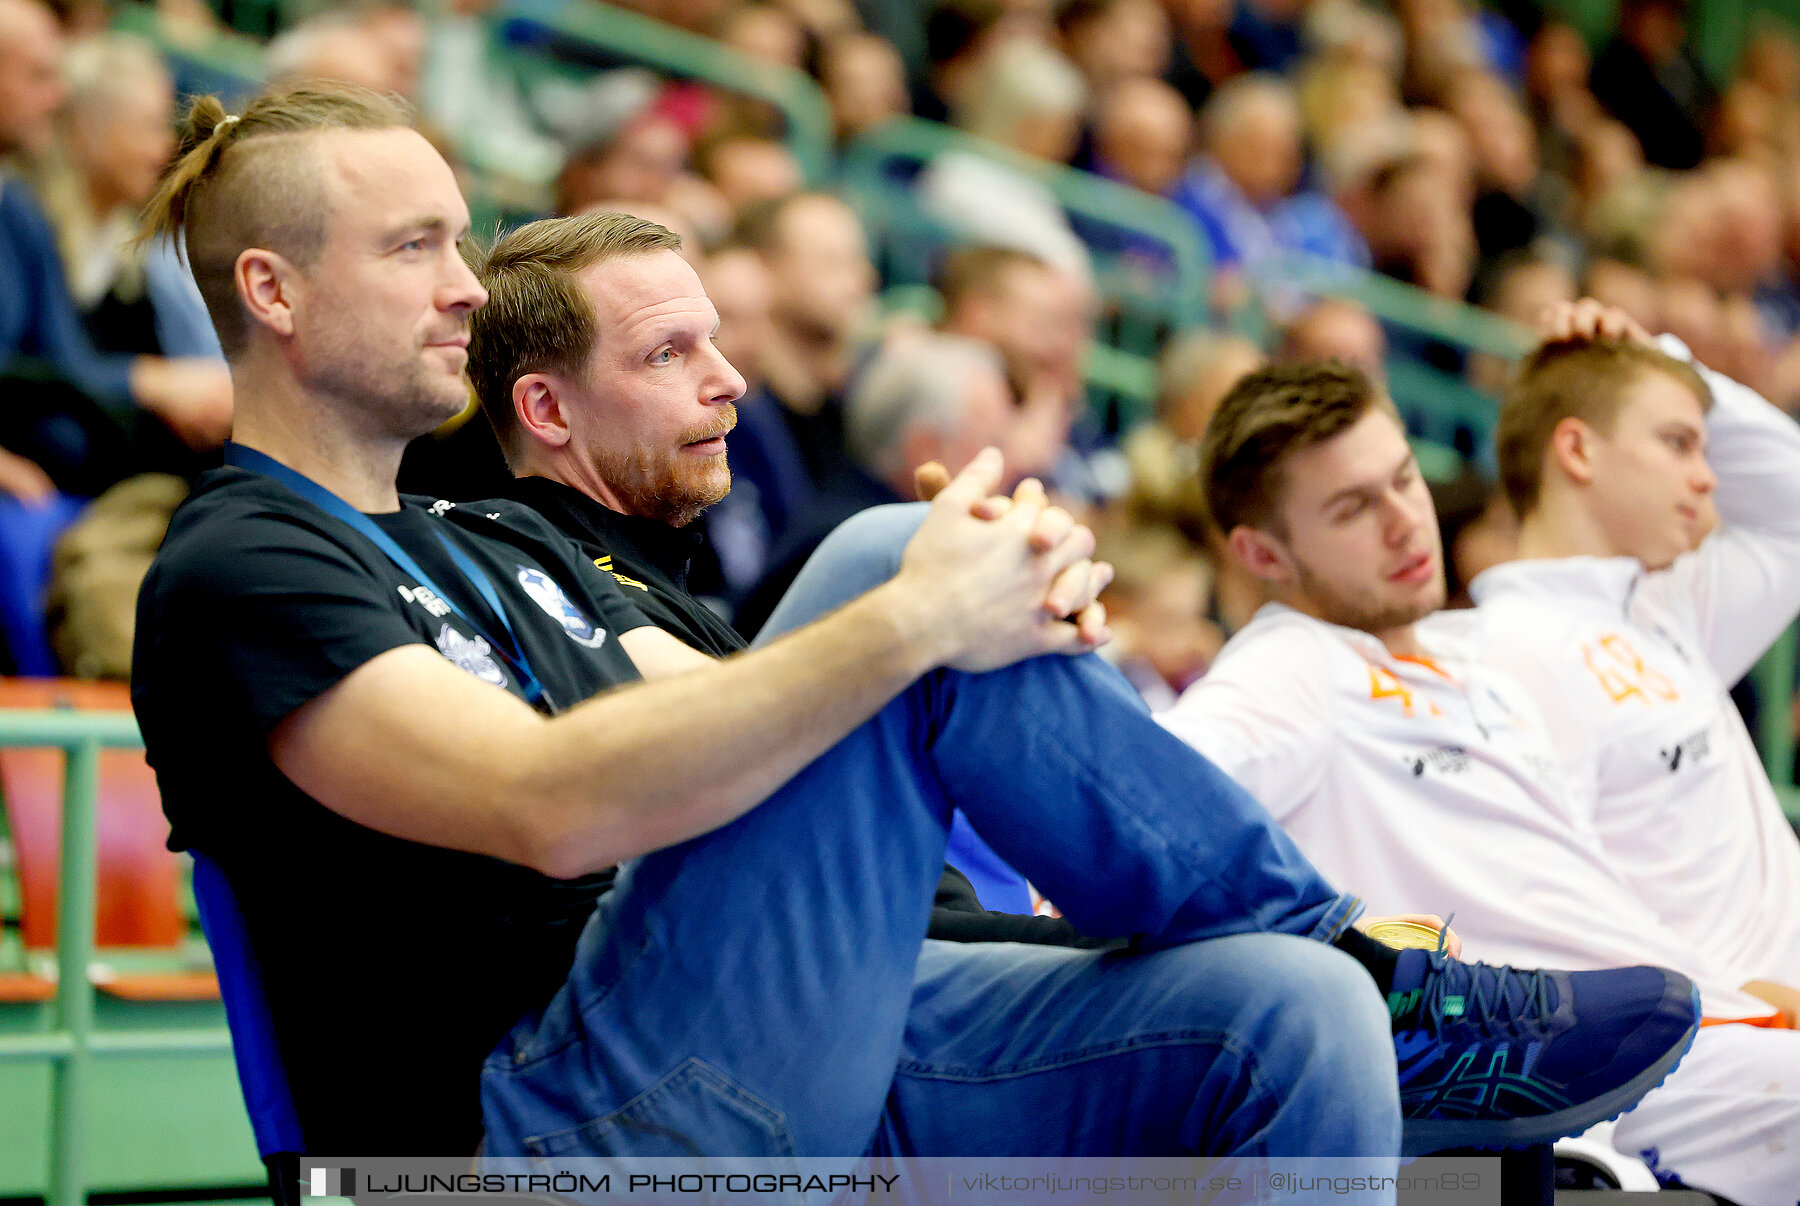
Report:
0,0,1800,738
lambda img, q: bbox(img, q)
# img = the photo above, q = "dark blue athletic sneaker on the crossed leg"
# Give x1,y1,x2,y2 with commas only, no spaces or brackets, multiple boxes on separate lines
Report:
1388,941,1699,1156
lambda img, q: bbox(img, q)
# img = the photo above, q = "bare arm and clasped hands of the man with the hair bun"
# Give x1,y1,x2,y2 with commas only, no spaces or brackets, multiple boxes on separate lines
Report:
270,455,1103,875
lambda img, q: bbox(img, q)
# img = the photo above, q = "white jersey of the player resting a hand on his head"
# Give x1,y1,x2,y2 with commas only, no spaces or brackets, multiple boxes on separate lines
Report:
1472,340,1800,986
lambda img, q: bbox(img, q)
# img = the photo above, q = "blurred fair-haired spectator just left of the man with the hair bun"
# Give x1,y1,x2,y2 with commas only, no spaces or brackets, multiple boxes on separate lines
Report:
34,34,220,370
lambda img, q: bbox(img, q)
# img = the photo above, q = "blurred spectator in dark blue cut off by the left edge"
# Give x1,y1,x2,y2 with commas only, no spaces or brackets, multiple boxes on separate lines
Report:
0,0,230,495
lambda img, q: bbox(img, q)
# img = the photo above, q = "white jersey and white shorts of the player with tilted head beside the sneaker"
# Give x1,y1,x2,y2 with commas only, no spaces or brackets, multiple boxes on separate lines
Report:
1157,603,1800,1206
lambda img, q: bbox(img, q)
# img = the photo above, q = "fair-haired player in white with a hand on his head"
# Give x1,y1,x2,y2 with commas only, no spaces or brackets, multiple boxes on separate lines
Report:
1471,311,1800,1024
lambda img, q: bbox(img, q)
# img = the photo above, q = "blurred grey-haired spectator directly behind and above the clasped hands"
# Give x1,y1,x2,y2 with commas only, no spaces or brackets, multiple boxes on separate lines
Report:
736,331,1015,635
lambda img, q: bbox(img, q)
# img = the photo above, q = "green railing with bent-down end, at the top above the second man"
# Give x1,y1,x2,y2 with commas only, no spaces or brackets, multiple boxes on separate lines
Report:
497,0,833,184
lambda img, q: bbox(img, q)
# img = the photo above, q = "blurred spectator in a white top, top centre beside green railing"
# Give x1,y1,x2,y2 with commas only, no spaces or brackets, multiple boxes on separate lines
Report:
914,38,1089,275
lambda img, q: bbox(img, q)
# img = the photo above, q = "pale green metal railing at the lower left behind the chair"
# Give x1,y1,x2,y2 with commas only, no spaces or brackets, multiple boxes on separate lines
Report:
0,709,230,1206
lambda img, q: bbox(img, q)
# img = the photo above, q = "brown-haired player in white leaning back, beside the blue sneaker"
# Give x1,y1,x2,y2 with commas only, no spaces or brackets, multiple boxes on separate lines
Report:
1159,307,1800,1206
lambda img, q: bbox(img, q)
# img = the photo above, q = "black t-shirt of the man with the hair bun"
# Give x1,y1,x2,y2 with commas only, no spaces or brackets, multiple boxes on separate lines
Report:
131,468,648,1156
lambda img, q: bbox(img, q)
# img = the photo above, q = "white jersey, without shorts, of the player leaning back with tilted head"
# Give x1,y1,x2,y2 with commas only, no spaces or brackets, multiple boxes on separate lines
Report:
1157,603,1769,1017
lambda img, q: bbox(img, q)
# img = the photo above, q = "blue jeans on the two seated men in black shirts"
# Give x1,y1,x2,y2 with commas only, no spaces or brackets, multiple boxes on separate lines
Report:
482,508,1400,1157
